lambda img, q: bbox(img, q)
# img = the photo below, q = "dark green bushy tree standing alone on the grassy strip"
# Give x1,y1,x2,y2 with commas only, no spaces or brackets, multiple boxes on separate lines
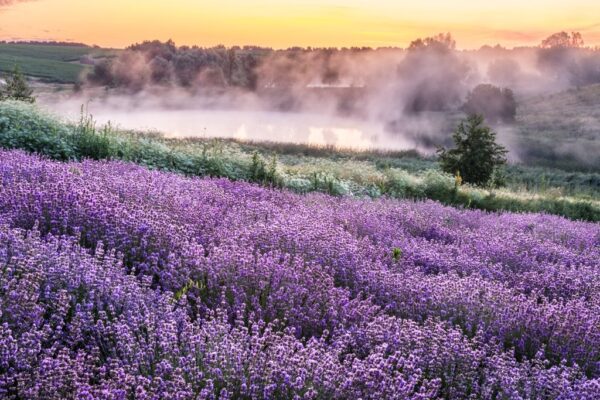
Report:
438,114,508,186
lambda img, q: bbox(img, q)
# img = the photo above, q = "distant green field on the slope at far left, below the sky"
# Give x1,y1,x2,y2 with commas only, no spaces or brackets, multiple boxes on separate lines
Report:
0,44,113,83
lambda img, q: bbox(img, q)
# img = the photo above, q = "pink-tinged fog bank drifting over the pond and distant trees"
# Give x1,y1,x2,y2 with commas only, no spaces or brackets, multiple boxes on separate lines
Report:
40,32,600,168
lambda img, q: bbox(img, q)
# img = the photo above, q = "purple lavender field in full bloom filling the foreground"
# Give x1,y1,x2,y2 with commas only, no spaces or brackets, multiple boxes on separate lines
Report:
0,151,600,400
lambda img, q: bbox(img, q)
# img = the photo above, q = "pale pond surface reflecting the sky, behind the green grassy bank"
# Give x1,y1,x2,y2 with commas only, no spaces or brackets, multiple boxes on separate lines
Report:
46,103,422,150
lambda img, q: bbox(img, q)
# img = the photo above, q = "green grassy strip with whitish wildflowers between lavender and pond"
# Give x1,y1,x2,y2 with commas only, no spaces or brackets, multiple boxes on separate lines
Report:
0,98,600,221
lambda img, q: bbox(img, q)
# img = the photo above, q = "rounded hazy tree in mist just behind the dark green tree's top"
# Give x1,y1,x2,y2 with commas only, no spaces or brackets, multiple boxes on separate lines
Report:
463,84,517,123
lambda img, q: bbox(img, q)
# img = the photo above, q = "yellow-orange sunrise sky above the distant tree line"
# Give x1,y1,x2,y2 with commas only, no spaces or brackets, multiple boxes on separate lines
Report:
0,0,600,49
